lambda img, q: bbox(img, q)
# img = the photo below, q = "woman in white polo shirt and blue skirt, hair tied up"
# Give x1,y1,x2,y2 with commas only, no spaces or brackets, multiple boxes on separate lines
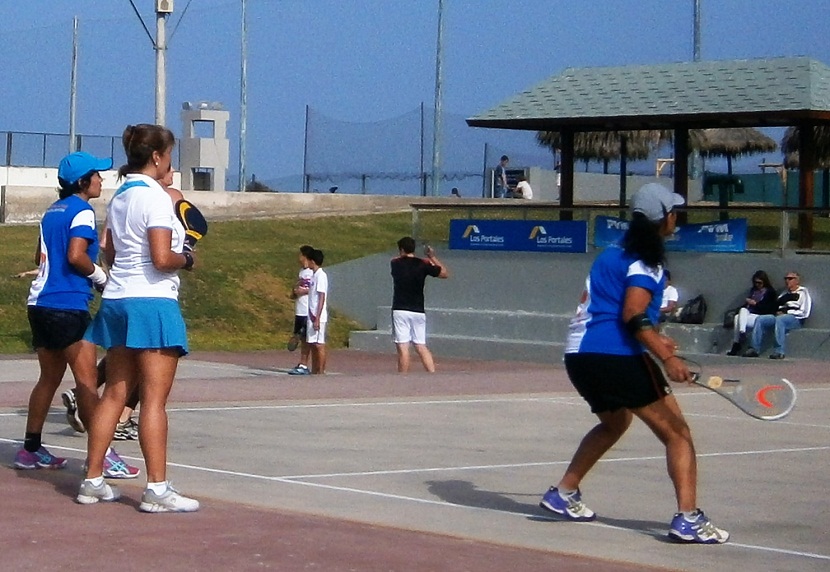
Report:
77,124,199,512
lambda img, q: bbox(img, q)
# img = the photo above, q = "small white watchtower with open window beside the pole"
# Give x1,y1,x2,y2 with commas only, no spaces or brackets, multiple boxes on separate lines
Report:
180,101,230,191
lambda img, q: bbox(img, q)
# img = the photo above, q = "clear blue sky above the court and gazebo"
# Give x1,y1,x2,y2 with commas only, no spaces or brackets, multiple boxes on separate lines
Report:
0,0,830,190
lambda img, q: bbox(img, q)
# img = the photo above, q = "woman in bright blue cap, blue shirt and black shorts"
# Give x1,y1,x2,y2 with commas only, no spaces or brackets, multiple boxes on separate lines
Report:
14,152,139,478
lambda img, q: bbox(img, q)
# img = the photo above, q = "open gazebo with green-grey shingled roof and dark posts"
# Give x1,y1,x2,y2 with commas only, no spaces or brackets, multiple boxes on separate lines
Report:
467,57,830,248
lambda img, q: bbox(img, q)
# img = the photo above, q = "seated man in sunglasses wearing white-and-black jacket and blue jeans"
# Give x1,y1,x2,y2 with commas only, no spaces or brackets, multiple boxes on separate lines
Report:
744,272,813,359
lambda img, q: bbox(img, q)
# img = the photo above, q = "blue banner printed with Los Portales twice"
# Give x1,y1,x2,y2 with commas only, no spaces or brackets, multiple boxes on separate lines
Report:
450,219,588,252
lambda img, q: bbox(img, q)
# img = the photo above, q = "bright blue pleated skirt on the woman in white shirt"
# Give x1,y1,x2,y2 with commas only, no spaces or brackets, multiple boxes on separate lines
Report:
84,298,188,355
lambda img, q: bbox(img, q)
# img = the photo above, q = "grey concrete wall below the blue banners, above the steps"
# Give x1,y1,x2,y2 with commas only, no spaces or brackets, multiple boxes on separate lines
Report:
326,250,830,330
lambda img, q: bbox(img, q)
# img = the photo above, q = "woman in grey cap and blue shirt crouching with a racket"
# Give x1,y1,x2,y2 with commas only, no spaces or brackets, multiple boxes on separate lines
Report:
540,183,729,544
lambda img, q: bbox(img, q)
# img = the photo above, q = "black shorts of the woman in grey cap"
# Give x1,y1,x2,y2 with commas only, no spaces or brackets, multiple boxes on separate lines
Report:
565,353,672,413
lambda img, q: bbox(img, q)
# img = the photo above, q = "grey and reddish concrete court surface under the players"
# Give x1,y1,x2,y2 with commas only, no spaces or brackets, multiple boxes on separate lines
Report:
0,350,830,572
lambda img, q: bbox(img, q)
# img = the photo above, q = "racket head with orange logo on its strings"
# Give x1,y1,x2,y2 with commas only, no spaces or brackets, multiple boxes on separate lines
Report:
713,376,797,421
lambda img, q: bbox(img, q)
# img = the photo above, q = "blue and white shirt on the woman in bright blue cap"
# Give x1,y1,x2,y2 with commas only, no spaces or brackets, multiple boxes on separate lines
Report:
28,195,98,310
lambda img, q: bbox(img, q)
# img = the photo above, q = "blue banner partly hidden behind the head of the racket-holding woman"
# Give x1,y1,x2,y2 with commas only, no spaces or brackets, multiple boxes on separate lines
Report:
594,216,747,252
